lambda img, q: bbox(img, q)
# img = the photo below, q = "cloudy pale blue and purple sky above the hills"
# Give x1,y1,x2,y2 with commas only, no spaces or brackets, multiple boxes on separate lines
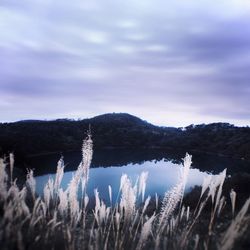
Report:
0,0,250,127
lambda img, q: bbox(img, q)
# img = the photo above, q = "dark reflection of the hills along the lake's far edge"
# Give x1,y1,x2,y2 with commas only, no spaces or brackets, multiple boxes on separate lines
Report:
28,149,250,175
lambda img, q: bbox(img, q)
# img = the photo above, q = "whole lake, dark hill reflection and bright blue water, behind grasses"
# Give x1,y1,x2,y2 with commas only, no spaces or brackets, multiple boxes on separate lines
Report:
28,149,249,200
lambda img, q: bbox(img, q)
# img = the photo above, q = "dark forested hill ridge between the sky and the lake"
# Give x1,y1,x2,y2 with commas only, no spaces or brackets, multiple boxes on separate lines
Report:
0,113,250,159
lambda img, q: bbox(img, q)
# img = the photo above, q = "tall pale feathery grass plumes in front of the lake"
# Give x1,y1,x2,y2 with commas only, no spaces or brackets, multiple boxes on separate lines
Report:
0,134,250,250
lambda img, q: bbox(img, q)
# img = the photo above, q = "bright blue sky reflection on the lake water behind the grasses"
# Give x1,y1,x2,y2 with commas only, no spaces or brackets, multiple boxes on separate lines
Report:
36,160,210,201
